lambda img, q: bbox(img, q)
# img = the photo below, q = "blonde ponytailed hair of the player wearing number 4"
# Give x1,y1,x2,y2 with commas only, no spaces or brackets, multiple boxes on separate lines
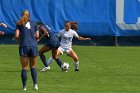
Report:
17,10,30,25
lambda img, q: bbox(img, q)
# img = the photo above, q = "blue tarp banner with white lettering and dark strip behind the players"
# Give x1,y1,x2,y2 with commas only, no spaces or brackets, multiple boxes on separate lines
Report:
0,0,140,46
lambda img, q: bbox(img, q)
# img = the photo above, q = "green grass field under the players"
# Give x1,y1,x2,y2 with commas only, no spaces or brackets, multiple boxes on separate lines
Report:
0,45,140,93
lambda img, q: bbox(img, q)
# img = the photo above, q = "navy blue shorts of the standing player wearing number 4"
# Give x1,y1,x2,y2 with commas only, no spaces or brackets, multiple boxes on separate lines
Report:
19,46,38,57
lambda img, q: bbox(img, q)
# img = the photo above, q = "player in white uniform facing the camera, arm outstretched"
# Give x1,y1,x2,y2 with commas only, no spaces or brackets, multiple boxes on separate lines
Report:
48,21,91,71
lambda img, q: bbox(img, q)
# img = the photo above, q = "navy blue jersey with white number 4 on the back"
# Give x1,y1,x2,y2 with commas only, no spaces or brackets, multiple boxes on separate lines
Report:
16,21,39,47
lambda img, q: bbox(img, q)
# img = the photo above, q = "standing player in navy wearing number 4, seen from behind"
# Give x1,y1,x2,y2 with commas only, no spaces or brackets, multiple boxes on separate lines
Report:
15,10,39,90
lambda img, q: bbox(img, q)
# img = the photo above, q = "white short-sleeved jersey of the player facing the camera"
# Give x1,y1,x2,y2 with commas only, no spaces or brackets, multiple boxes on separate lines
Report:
58,29,79,48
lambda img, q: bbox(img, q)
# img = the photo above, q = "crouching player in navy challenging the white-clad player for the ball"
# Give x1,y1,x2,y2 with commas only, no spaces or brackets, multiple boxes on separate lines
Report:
38,23,63,71
